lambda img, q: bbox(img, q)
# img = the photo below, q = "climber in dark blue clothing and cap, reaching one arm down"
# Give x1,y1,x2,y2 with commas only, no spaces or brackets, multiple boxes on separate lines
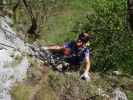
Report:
44,32,95,81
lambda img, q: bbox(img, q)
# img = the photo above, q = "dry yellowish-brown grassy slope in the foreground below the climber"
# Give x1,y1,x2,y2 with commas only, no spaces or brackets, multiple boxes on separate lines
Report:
12,69,133,100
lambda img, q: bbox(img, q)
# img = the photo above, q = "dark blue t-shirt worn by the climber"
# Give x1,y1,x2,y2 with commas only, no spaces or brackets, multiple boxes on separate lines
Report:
64,41,90,65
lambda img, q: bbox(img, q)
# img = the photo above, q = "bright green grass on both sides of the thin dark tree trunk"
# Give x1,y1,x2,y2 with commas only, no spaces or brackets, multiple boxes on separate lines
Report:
13,0,92,44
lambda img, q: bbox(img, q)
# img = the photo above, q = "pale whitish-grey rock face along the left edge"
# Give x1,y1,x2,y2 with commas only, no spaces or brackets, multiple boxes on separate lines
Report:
0,16,29,100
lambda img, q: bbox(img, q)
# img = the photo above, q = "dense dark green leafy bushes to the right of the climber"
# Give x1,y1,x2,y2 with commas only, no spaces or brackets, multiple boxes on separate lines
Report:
73,0,133,73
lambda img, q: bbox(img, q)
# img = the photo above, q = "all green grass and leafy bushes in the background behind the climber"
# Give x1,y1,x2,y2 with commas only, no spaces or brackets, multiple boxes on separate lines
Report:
8,0,133,73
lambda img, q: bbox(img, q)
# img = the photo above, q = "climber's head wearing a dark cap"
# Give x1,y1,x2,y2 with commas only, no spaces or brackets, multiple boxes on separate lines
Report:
76,32,95,47
